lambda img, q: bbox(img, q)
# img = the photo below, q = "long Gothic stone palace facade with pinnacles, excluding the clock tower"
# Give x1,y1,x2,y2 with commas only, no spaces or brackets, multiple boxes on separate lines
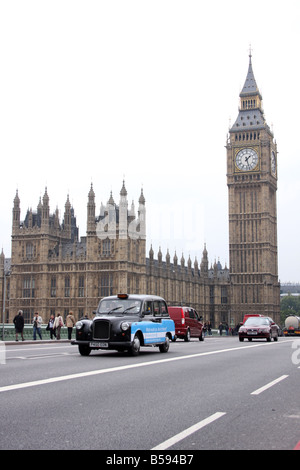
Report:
0,182,230,325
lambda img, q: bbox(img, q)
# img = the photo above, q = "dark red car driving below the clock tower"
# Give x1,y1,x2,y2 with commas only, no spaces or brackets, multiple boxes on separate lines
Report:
239,316,279,341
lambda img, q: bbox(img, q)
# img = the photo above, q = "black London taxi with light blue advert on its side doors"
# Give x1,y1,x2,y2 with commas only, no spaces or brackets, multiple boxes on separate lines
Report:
72,294,175,356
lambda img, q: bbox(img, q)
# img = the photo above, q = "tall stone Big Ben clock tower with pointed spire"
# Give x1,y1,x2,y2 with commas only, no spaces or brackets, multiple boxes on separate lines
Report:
226,54,280,322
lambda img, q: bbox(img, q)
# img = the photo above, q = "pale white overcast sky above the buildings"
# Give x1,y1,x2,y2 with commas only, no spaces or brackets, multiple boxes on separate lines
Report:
0,0,300,282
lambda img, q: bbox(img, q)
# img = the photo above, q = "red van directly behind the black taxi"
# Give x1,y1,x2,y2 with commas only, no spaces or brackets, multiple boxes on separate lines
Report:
168,307,204,341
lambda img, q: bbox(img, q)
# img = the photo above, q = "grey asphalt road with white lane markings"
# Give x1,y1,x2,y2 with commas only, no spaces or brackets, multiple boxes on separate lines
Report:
0,336,300,453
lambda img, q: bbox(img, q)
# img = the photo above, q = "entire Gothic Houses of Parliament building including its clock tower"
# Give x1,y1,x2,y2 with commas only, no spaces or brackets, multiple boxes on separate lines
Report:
0,55,280,327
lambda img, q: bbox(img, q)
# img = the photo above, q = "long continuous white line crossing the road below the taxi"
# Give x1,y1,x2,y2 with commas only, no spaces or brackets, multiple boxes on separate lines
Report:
0,342,283,393
